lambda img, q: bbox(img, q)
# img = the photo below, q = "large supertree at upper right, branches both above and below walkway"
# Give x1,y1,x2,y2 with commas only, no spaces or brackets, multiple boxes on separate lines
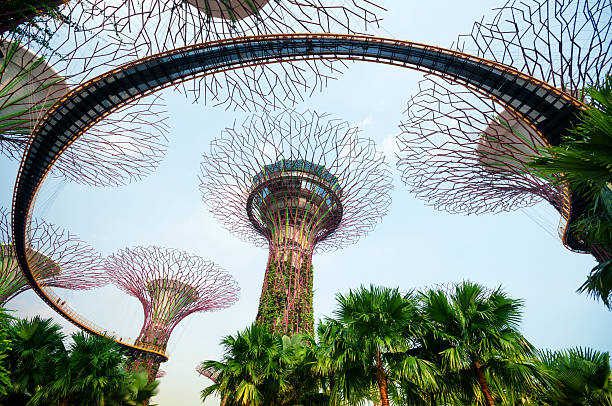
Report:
398,0,612,259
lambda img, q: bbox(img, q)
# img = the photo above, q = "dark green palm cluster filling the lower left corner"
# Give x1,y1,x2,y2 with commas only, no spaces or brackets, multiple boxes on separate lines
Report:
0,317,157,406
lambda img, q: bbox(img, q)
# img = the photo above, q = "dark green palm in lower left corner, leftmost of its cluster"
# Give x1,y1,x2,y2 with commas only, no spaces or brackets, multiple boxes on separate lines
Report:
5,316,66,404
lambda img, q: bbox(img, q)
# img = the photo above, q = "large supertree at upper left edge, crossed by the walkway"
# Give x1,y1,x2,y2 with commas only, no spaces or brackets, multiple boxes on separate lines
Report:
0,12,167,185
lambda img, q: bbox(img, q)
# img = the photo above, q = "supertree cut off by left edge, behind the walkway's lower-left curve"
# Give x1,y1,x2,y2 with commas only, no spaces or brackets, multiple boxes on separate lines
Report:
0,208,108,305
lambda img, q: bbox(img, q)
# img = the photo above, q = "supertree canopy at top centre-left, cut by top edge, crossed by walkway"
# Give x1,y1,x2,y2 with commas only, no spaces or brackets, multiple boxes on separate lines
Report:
91,0,384,110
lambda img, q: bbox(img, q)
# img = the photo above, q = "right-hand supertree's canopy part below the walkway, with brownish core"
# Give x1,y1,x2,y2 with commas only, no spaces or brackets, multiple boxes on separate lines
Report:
397,78,564,214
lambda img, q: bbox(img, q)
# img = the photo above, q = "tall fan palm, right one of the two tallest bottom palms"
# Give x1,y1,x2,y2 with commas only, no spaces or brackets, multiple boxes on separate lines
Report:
421,281,538,406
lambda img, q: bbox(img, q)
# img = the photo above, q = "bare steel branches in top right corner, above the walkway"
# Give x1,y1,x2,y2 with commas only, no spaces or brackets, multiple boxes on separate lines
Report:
457,0,612,100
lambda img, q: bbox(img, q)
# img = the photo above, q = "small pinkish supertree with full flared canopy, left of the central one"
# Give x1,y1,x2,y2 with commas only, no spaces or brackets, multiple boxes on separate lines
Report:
107,247,240,380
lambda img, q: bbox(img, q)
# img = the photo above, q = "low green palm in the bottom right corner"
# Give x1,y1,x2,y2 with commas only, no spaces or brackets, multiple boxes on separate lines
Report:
539,348,612,406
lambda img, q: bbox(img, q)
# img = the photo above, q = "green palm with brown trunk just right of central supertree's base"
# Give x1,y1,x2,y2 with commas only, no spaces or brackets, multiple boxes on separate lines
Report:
335,285,435,406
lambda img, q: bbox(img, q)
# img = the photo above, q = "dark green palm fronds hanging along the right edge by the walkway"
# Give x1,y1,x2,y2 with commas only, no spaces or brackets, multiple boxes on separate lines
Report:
532,76,612,308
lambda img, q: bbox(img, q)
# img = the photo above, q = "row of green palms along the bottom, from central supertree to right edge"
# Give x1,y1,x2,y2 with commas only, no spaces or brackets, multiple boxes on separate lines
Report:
202,282,612,406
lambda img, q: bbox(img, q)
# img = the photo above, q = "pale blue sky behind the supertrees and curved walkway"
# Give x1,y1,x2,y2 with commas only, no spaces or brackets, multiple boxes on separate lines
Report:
0,0,612,406
